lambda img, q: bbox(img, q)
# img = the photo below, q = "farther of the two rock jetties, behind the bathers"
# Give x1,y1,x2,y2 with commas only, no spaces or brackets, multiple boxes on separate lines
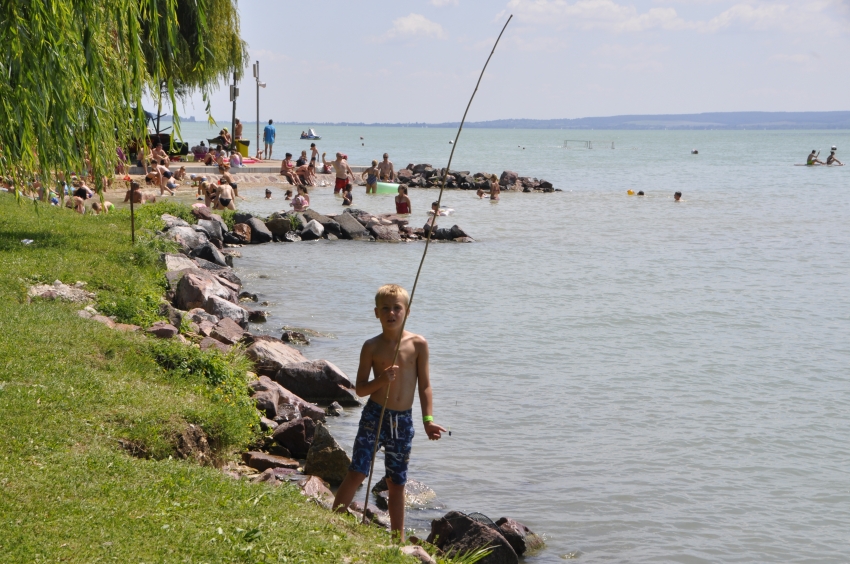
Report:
397,163,561,192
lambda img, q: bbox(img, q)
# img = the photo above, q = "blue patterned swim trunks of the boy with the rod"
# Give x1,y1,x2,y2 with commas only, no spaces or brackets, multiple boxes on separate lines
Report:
348,399,414,486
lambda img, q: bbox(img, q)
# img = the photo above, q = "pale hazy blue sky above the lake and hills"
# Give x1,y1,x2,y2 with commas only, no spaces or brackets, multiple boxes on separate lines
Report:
169,0,850,123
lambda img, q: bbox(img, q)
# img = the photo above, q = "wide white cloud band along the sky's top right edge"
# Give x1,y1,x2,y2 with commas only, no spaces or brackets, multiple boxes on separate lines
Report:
502,0,846,33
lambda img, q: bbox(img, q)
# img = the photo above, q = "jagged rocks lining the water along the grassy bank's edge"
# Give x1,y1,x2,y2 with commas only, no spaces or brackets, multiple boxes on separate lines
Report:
53,213,543,563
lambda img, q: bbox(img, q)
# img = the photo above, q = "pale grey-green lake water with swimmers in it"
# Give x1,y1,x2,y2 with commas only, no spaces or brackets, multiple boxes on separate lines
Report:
184,125,850,563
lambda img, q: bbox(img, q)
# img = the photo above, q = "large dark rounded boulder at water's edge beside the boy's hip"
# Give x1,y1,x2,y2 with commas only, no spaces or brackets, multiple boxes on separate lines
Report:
274,362,360,407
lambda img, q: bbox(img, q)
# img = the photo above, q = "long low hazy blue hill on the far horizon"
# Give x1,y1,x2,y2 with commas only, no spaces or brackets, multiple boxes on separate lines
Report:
278,112,850,129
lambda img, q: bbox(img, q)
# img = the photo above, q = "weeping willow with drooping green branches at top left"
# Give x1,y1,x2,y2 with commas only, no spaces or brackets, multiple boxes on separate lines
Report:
0,0,247,196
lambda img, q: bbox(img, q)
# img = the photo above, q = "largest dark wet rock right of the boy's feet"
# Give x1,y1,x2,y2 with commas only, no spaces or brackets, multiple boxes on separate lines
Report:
426,511,519,564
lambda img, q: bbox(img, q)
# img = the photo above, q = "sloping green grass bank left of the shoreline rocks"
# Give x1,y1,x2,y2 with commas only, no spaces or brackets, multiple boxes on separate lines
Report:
0,194,409,563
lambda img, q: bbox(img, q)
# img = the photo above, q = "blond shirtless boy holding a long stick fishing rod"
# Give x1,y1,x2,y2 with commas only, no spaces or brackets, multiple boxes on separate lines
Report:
333,284,446,541
